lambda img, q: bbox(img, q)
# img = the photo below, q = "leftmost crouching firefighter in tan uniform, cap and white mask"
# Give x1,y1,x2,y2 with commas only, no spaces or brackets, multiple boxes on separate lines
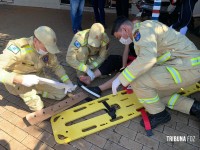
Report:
0,26,74,111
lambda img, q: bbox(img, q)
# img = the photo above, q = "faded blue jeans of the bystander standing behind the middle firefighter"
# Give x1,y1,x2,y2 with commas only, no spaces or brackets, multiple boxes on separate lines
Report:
70,0,85,33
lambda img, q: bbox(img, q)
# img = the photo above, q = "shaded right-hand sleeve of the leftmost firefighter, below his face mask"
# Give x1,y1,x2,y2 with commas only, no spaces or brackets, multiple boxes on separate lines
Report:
49,55,71,83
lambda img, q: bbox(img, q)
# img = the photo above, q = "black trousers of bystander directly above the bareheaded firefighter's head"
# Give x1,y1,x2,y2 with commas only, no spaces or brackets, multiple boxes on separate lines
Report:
116,0,129,18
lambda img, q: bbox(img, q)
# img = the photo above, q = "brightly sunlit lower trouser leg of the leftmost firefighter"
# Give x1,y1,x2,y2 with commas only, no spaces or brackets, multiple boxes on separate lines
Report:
19,89,44,111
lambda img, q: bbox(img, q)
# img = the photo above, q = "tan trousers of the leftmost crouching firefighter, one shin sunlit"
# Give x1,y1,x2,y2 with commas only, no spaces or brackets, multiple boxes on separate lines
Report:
5,75,66,111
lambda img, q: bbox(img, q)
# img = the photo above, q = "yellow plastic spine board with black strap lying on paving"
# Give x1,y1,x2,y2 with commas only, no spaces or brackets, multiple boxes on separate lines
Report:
51,91,143,144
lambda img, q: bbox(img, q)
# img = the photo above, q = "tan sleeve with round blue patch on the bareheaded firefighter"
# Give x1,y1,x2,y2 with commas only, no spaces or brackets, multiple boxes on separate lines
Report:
119,28,157,86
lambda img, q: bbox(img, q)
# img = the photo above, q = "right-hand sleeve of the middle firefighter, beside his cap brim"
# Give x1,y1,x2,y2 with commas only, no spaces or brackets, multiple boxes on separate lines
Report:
91,33,110,69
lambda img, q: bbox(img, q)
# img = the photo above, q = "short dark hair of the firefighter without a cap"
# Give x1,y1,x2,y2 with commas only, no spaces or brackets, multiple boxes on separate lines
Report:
111,16,132,35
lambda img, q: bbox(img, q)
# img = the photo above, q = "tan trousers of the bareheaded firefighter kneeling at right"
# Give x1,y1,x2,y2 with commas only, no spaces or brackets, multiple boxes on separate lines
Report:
131,66,200,114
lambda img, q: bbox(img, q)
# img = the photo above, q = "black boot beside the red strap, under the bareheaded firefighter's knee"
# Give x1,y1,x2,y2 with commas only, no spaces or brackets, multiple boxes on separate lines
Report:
140,109,171,129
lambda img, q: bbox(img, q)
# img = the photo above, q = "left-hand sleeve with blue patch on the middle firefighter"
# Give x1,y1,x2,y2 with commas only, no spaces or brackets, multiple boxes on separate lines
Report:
66,35,88,72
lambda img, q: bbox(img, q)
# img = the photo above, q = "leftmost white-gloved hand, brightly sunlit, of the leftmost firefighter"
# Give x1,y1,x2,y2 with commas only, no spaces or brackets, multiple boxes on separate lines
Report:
21,75,40,87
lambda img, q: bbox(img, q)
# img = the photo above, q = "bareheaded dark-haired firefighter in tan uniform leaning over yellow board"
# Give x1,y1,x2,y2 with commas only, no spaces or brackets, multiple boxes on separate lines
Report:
112,17,200,128
